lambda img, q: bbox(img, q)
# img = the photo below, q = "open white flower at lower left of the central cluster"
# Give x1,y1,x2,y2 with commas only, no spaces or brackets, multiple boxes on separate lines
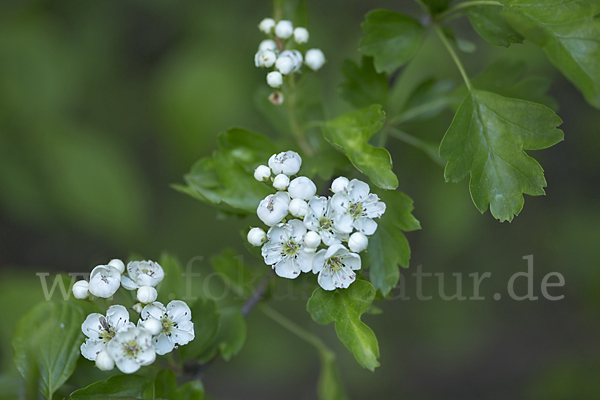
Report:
261,219,314,279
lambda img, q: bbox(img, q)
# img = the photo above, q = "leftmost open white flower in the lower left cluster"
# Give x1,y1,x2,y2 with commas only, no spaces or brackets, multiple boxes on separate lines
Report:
81,305,133,361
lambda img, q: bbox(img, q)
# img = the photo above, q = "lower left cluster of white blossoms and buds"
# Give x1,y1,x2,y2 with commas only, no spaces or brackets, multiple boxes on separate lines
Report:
73,260,195,374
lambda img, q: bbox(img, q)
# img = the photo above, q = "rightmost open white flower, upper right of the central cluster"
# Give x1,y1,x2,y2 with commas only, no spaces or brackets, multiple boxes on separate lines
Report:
331,179,385,235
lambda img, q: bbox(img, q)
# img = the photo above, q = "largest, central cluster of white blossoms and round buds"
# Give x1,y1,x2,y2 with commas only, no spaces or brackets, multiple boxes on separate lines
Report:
248,151,385,290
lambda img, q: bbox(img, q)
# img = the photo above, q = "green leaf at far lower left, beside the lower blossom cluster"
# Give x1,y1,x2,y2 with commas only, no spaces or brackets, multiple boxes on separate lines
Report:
12,302,84,398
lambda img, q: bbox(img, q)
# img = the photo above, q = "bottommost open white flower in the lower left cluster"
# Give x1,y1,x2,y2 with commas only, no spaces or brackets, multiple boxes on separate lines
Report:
106,326,156,374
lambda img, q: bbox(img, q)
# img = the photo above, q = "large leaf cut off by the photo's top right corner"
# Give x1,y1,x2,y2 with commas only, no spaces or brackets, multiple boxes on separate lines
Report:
502,0,600,108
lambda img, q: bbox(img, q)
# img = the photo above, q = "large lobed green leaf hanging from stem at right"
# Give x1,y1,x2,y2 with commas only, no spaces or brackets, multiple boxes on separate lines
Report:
440,90,563,221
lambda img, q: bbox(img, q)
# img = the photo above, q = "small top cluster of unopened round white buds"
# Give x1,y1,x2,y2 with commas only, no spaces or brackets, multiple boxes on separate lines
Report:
254,18,325,99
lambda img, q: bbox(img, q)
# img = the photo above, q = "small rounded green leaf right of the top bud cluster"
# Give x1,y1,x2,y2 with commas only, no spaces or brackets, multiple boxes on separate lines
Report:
359,10,424,72
